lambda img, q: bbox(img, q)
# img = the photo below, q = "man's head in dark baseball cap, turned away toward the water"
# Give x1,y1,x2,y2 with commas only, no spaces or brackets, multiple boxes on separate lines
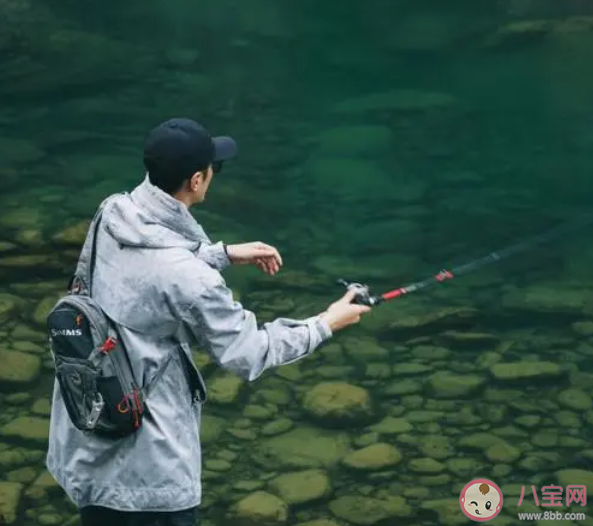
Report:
144,118,237,206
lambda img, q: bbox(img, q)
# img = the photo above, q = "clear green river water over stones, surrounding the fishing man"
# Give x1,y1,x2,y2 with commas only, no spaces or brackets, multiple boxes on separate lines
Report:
0,0,593,526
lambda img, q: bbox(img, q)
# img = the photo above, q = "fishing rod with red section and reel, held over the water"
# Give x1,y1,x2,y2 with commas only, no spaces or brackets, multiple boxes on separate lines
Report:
337,214,593,307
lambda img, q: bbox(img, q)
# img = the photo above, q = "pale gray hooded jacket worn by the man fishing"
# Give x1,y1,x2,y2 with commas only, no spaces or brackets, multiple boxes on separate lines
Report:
47,178,331,511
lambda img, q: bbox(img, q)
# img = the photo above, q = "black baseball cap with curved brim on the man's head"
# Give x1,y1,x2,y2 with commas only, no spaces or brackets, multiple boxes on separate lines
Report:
144,118,237,177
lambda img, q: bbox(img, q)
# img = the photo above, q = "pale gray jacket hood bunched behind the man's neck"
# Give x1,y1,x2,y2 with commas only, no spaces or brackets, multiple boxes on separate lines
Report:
102,176,210,251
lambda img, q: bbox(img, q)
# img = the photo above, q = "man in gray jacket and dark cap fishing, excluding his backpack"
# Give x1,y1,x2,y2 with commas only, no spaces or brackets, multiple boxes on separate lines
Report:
47,119,369,526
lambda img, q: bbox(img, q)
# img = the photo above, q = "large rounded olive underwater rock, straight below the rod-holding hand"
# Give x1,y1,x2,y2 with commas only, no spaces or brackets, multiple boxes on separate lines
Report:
303,382,374,425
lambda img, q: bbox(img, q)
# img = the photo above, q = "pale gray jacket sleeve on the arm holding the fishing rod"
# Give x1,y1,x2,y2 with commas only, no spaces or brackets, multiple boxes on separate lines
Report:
179,271,332,381
